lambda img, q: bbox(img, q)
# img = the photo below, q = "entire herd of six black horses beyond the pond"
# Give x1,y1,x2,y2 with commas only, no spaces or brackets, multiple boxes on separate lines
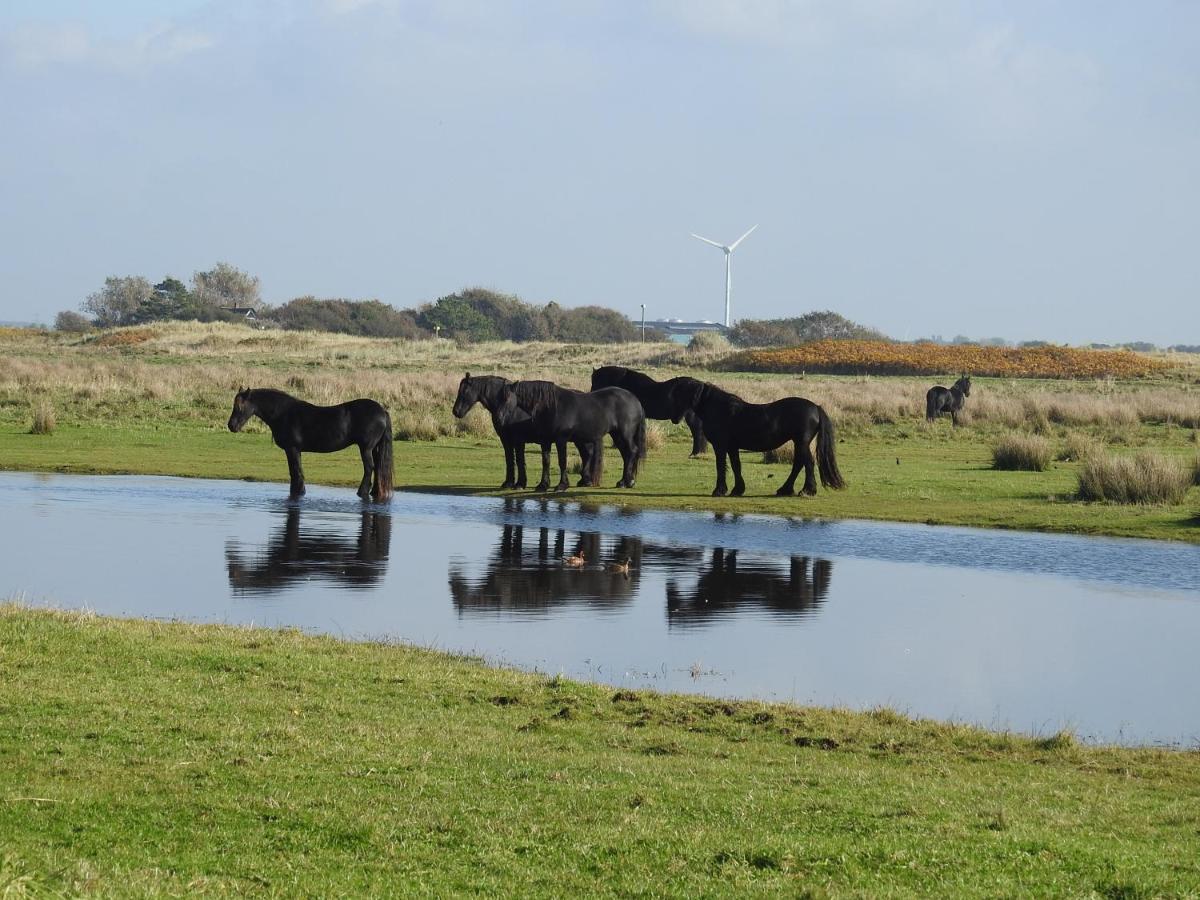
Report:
229,366,971,502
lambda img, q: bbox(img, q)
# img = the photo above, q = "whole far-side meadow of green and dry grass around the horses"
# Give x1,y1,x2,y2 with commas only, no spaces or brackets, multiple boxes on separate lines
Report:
7,324,1200,542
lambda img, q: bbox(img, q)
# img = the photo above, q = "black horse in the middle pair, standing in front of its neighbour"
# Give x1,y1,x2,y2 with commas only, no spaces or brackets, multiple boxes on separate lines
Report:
497,382,646,491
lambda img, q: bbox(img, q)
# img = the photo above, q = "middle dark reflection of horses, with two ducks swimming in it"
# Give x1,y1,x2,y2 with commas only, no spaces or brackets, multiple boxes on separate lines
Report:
450,524,642,613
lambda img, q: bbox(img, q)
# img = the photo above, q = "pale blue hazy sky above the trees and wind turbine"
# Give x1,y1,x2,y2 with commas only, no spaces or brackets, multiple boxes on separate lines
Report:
0,0,1200,344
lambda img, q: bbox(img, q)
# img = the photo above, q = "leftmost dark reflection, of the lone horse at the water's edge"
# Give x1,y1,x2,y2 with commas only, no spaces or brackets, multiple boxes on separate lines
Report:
226,506,391,594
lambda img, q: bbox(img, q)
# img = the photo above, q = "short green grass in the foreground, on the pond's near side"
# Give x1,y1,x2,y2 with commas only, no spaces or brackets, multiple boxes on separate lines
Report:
0,605,1200,896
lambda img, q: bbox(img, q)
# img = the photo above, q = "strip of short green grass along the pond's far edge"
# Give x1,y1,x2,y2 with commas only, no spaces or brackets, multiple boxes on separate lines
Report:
0,416,1200,542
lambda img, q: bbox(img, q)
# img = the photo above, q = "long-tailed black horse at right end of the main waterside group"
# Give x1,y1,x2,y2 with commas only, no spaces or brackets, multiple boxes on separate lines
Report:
667,382,846,497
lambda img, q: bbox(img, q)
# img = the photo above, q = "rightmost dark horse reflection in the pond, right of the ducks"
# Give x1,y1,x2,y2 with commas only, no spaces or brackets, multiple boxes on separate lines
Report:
667,547,833,628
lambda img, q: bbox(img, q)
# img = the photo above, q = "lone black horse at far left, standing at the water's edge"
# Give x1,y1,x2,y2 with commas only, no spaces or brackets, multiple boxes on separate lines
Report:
229,388,392,503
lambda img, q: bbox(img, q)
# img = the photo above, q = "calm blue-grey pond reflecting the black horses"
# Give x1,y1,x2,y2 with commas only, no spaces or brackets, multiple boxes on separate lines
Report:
0,474,1200,746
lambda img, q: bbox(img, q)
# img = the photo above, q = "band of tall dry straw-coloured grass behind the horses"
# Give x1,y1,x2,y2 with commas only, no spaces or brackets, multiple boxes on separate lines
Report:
0,323,1200,442
